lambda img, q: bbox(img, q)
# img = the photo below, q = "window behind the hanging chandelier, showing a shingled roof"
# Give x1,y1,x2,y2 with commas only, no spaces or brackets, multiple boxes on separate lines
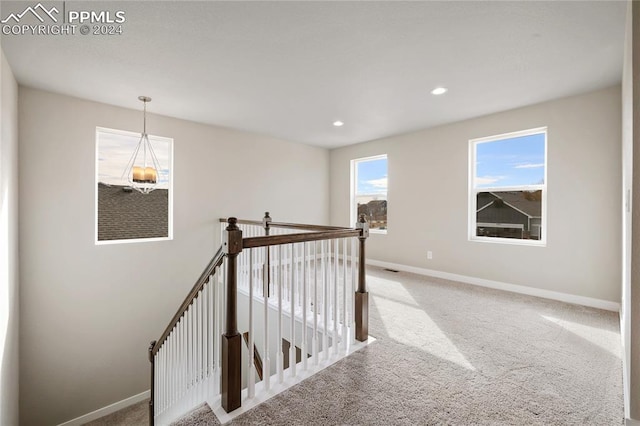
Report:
96,127,173,244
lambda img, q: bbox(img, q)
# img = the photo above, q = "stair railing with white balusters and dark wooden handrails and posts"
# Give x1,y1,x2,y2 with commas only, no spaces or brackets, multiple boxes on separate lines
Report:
149,213,368,425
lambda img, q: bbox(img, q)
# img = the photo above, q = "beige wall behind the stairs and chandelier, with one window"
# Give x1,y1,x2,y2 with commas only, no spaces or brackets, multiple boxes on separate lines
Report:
19,87,329,425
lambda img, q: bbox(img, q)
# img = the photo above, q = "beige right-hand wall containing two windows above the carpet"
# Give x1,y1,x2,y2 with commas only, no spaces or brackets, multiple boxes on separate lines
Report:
331,86,621,302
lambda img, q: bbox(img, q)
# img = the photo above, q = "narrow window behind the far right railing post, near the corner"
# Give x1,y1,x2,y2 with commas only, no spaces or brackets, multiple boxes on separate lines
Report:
351,155,387,233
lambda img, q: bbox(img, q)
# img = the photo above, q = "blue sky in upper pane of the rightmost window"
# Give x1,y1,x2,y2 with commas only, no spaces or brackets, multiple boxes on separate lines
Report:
475,133,545,188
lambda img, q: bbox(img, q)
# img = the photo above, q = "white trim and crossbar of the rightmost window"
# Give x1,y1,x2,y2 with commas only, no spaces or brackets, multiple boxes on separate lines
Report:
467,126,549,247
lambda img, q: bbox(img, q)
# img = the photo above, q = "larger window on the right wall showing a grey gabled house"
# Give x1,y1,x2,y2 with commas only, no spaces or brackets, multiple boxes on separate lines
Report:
469,128,547,245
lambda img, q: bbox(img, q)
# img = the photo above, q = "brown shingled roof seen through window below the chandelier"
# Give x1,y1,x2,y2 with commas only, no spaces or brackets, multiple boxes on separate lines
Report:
98,183,169,241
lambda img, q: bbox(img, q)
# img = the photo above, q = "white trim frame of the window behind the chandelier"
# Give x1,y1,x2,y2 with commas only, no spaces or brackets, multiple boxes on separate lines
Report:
93,127,174,246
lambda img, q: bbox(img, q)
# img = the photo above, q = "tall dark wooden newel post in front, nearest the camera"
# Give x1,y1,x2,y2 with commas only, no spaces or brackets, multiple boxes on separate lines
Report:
221,217,242,413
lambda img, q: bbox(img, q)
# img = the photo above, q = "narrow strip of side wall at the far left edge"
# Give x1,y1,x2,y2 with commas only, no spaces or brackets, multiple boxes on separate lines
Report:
0,52,19,426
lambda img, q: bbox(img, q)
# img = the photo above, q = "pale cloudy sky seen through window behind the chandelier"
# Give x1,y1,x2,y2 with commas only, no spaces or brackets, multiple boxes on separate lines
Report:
97,131,171,189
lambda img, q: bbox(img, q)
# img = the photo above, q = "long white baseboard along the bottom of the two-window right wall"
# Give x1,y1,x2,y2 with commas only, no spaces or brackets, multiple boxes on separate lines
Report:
367,259,620,312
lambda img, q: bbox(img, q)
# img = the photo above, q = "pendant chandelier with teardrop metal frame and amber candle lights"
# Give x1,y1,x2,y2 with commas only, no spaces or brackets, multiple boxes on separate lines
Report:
122,96,160,194
